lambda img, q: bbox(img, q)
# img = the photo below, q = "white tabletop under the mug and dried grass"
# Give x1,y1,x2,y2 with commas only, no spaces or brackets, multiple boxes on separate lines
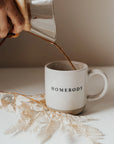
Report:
0,67,114,144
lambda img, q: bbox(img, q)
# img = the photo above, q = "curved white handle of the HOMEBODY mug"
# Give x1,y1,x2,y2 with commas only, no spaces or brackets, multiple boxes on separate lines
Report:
87,69,108,101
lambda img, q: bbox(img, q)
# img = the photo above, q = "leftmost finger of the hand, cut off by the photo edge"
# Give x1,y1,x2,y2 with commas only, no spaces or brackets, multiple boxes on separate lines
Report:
0,7,9,38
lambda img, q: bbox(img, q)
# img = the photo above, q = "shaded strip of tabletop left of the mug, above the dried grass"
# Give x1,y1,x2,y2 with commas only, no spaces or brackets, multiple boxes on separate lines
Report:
0,68,44,94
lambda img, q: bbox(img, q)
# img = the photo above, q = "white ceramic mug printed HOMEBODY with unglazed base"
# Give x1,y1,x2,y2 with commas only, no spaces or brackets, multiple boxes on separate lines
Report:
45,61,108,114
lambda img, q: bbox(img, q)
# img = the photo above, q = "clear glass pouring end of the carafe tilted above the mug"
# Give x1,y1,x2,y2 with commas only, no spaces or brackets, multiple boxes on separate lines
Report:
28,0,56,42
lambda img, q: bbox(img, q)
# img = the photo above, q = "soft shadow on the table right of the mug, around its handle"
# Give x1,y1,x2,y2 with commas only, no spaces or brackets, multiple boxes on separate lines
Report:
83,67,114,115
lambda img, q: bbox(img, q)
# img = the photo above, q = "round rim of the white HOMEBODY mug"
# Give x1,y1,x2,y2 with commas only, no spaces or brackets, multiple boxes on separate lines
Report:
45,60,88,72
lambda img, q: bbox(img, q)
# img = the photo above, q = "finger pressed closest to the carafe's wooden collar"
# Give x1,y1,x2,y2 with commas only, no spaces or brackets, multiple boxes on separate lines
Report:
6,0,24,34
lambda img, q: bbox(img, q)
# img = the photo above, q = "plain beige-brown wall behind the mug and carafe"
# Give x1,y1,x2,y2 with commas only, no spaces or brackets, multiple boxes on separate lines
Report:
0,0,114,66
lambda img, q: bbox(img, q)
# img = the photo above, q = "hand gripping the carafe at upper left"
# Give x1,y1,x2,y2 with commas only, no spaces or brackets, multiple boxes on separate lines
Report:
0,0,24,38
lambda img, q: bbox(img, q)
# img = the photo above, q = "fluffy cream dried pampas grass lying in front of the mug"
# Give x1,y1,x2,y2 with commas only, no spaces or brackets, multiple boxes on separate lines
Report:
0,92,103,144
